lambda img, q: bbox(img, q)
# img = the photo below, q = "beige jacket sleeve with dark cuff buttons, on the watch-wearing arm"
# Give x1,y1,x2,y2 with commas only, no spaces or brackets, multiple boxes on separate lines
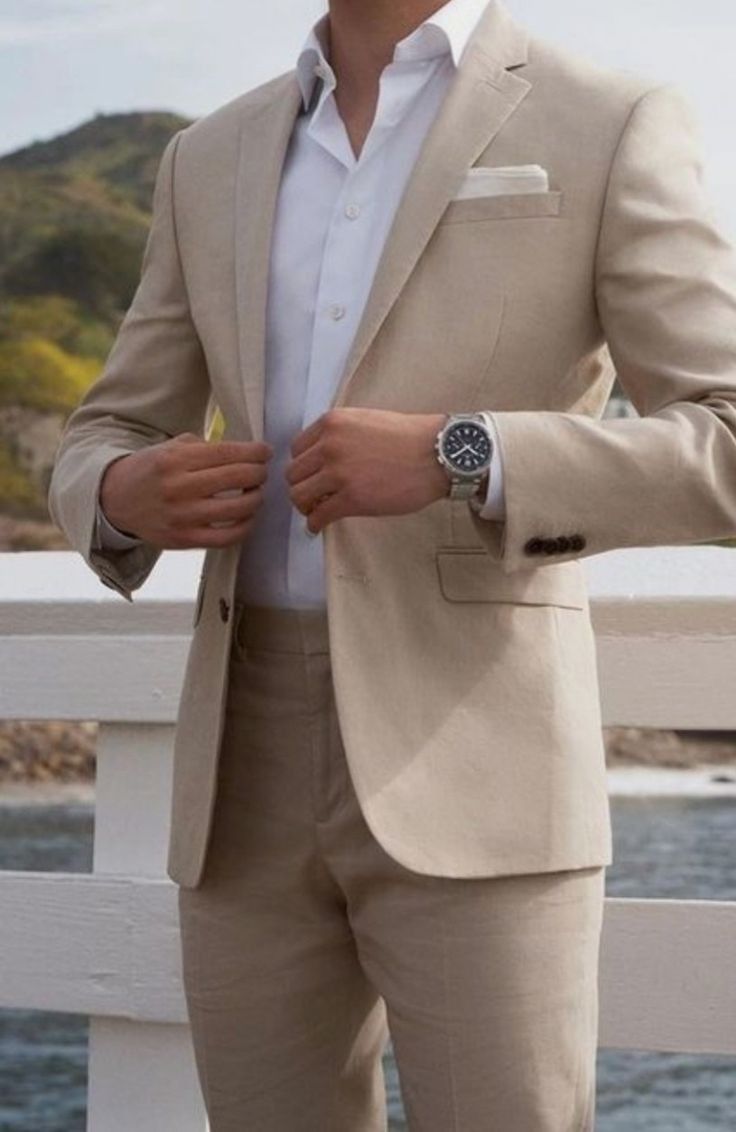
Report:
466,84,736,573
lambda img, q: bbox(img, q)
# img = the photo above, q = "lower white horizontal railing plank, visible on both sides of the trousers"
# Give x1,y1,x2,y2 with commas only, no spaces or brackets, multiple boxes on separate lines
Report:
0,873,736,1055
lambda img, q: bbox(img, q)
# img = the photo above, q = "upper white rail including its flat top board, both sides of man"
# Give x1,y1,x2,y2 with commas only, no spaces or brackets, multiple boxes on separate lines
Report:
0,547,736,730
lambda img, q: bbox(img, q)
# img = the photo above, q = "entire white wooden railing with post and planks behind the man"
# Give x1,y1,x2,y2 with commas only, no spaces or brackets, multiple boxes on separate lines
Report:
0,547,736,1132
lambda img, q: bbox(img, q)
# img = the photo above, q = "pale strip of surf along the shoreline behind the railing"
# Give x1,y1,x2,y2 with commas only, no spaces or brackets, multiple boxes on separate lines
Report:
0,763,736,808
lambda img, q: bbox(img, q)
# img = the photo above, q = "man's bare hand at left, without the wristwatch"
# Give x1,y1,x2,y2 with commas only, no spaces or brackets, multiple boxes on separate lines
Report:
100,432,273,550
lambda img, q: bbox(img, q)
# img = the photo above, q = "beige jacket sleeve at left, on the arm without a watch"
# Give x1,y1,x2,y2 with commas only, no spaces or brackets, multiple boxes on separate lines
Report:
48,130,211,601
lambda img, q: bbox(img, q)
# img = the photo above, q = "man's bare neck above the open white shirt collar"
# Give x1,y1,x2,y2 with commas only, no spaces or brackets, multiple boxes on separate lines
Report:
328,0,446,105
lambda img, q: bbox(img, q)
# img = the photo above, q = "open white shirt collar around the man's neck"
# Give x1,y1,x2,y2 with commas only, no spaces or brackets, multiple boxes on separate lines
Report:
297,0,493,109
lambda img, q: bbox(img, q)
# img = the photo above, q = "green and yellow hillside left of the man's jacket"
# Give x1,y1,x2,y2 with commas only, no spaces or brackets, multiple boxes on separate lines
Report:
0,112,189,517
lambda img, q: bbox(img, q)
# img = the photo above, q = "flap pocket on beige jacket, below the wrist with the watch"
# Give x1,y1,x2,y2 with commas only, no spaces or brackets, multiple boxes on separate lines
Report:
436,548,588,609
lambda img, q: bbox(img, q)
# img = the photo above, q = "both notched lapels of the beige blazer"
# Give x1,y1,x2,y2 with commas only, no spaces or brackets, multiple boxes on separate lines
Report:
228,0,531,440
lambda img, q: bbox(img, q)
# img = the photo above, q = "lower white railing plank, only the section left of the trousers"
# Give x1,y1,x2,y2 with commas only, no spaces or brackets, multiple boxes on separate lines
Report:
0,872,187,1022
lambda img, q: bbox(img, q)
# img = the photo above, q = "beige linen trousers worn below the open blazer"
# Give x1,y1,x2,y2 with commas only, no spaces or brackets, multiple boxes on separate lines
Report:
179,602,605,1132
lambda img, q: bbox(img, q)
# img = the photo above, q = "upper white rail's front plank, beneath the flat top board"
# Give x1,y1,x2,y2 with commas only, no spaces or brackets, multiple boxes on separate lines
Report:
5,633,736,730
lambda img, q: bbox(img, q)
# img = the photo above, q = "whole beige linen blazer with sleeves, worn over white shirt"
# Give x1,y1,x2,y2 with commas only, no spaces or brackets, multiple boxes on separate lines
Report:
49,0,736,886
